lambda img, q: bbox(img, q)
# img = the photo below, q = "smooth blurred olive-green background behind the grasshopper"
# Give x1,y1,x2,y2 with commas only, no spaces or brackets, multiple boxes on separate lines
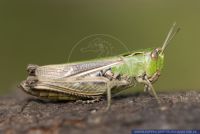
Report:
0,0,200,94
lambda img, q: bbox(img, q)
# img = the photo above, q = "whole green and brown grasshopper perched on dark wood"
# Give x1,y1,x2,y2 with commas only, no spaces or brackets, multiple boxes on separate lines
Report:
20,23,179,110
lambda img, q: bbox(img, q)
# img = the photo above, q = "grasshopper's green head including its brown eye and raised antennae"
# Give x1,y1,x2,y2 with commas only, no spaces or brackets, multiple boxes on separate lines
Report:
146,23,180,77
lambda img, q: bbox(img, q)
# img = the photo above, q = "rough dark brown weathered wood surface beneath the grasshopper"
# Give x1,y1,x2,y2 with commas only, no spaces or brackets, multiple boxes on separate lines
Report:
0,91,200,134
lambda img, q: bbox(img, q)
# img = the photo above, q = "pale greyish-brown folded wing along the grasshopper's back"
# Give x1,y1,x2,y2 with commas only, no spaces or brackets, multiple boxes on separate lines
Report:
35,57,123,80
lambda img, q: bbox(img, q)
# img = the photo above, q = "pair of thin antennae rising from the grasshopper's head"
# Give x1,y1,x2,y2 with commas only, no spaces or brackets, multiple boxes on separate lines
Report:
161,22,180,53
